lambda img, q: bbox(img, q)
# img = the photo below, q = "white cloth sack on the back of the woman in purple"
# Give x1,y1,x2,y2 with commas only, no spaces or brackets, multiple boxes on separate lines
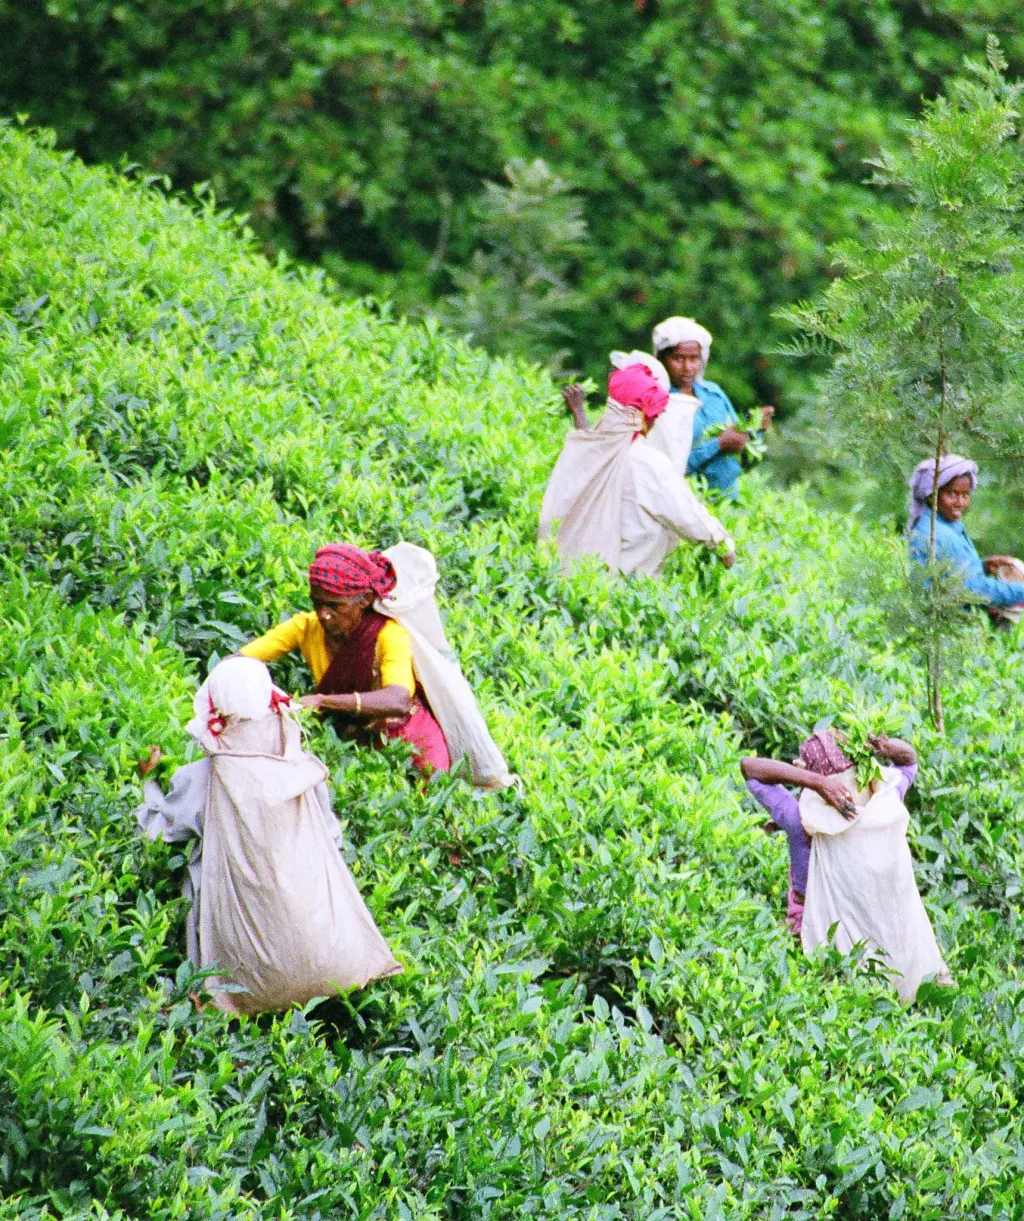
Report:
799,768,952,1004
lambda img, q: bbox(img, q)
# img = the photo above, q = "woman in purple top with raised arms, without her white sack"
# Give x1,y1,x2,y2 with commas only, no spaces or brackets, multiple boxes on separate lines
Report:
740,729,918,935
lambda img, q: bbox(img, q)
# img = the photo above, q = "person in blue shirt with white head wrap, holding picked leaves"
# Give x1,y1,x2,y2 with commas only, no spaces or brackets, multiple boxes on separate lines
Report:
651,316,775,497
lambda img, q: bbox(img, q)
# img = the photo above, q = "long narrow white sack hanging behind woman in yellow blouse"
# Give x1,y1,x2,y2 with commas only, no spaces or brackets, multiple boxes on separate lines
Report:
373,542,516,791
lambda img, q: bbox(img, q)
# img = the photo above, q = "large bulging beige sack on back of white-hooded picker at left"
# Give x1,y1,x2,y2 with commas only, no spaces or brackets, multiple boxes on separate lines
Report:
199,713,402,1013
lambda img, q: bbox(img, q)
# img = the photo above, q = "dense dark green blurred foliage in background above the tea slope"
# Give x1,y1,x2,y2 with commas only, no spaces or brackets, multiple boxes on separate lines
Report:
0,0,1024,402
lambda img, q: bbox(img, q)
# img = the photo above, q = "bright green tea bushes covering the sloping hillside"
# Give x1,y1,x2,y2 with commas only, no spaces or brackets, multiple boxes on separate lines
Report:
0,129,1024,1221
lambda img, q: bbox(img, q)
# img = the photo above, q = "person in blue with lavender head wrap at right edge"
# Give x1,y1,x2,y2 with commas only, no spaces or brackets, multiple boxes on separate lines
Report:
907,454,1024,612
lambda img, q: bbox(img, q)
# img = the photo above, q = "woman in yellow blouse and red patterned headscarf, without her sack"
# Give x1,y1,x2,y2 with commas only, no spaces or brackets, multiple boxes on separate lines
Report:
240,543,452,772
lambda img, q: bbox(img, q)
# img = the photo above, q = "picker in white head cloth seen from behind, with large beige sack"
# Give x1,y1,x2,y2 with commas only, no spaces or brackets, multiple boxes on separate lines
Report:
135,657,402,1013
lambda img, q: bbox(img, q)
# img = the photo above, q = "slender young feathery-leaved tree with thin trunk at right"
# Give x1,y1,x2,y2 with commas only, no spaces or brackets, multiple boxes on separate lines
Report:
782,38,1024,729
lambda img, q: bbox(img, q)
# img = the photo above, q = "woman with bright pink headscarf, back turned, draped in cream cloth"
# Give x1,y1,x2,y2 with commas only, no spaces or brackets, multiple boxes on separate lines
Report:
539,364,735,576
